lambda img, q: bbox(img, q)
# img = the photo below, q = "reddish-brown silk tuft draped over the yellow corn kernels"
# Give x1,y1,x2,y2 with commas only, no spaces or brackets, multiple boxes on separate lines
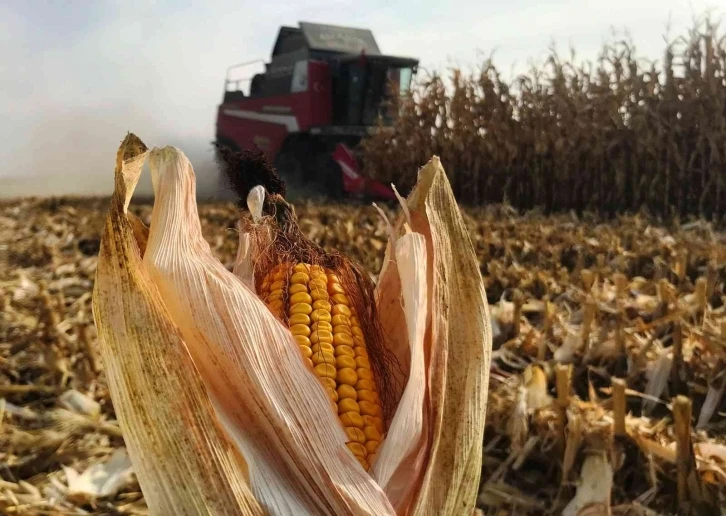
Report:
242,194,401,424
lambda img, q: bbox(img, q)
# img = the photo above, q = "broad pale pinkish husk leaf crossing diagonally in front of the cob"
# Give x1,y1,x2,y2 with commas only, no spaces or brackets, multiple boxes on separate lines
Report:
144,147,394,515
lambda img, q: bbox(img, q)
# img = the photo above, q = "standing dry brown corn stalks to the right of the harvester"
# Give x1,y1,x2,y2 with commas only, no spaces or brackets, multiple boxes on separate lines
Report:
362,20,726,221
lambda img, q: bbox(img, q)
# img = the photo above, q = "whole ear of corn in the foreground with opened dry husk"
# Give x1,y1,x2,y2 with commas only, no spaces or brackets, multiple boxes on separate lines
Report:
94,135,491,515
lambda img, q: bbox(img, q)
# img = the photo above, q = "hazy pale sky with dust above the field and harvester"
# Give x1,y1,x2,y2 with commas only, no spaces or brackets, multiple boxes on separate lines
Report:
0,0,724,198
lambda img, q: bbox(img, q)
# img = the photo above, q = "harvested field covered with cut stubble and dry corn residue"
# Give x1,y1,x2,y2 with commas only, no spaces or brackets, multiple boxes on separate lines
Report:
0,199,726,515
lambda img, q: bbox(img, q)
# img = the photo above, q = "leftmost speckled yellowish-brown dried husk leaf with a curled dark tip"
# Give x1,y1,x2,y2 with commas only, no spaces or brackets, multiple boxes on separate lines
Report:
93,134,262,515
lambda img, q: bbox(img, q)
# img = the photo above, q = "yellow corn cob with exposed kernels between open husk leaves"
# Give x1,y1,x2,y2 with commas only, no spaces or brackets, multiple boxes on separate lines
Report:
258,263,383,470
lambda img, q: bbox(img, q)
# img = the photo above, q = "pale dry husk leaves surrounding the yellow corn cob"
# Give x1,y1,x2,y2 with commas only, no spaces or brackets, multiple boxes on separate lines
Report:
91,135,491,515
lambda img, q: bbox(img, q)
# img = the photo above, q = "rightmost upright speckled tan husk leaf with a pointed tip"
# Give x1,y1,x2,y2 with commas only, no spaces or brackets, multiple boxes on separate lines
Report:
378,157,492,516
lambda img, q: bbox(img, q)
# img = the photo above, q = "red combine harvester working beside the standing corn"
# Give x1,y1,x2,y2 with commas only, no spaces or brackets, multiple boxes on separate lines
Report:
216,22,418,200
